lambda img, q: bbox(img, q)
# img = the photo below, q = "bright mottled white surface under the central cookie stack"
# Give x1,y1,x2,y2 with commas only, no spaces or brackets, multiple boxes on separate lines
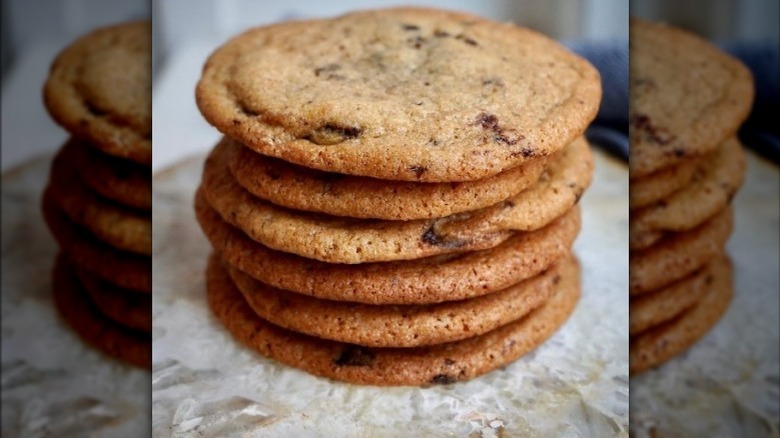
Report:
152,152,628,437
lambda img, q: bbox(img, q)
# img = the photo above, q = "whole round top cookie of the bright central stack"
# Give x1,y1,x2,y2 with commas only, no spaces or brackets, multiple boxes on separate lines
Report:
196,8,601,182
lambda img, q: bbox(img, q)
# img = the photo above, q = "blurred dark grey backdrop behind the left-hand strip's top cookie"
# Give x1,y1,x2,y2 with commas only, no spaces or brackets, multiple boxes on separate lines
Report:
0,0,152,172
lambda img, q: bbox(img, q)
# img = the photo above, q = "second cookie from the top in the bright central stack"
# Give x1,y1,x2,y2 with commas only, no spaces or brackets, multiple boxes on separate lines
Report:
225,137,557,220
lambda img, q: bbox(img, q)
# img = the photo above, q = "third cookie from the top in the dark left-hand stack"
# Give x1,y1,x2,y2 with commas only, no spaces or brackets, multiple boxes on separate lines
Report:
46,143,152,255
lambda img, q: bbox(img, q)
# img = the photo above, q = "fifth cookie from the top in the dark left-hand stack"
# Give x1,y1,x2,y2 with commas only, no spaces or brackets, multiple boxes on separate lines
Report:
73,265,152,333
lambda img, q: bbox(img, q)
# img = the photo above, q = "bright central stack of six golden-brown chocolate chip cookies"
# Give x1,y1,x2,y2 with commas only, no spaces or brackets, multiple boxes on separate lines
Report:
195,8,601,385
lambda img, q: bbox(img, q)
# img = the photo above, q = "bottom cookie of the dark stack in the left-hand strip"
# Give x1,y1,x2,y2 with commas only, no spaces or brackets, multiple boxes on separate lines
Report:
52,254,152,368
